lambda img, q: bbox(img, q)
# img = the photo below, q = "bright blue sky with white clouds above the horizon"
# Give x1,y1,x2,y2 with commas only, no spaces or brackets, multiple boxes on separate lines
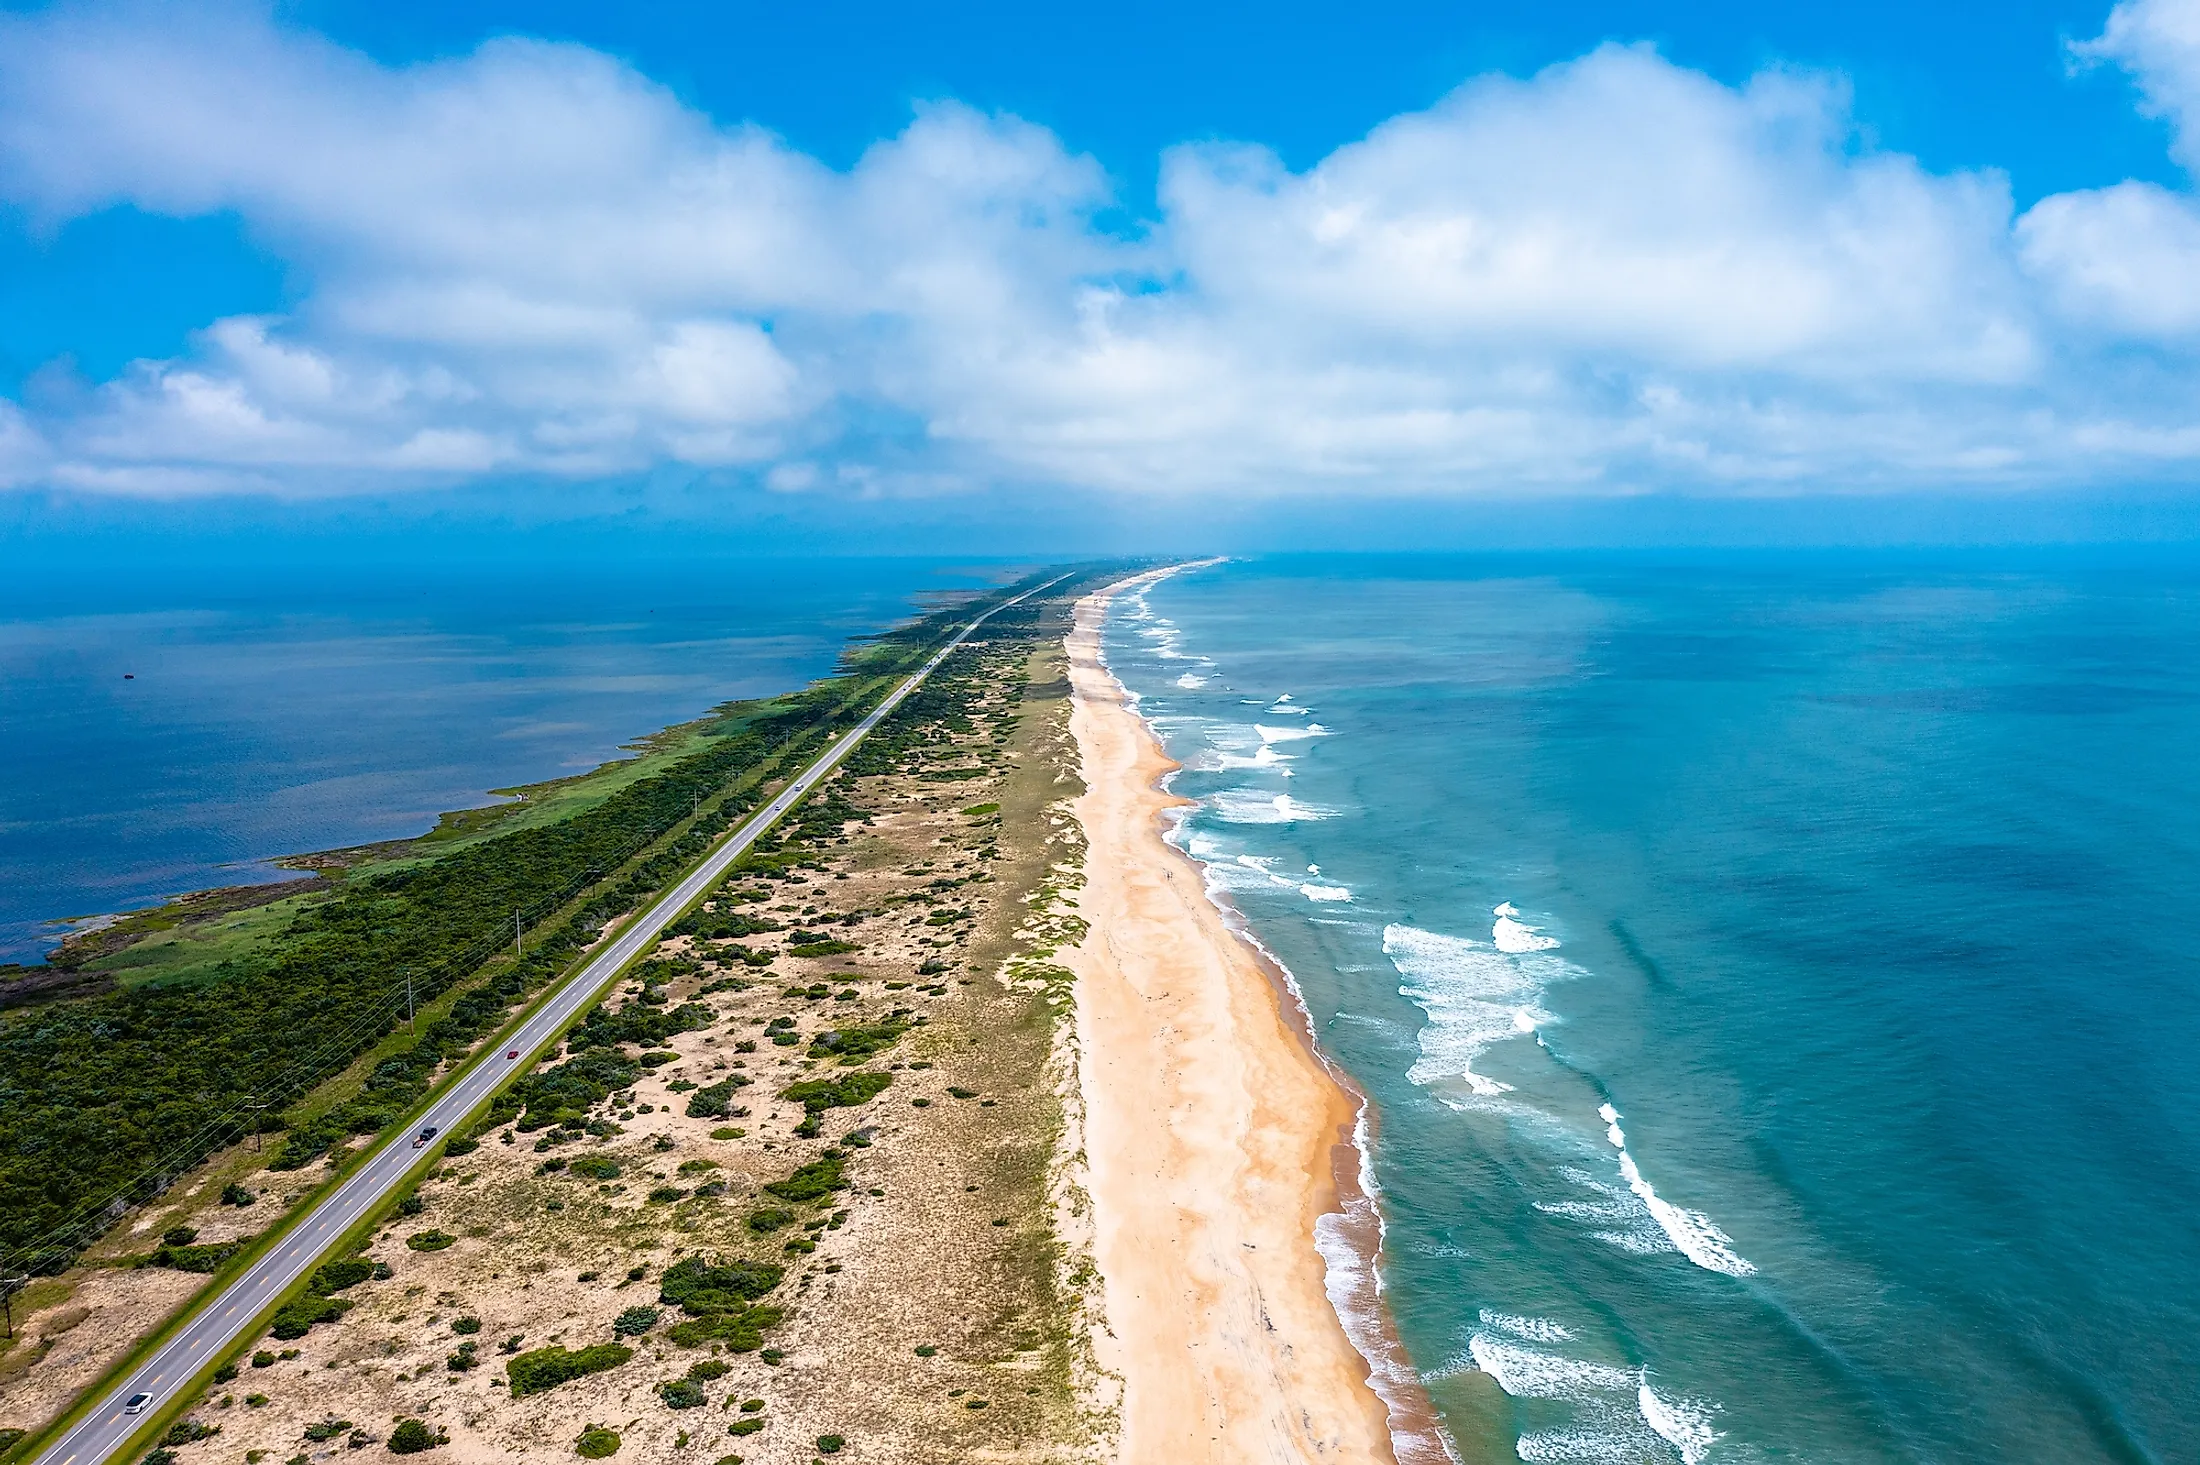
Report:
0,0,2200,543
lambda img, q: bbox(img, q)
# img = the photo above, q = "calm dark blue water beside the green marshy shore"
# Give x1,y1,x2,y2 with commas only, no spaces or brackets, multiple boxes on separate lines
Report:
0,552,975,961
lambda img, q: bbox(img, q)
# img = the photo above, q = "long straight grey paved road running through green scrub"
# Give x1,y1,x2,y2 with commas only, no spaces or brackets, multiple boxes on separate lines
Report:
37,576,1067,1465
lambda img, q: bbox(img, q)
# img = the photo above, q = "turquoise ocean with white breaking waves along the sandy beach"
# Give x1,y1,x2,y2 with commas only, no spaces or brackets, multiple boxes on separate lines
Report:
1107,552,2200,1465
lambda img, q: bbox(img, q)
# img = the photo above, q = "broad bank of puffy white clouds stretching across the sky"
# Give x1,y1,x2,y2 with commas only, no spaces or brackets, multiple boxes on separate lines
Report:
0,0,2200,493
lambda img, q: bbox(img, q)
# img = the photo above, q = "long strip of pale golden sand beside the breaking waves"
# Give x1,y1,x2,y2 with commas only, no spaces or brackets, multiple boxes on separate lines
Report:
1069,587,1393,1465
